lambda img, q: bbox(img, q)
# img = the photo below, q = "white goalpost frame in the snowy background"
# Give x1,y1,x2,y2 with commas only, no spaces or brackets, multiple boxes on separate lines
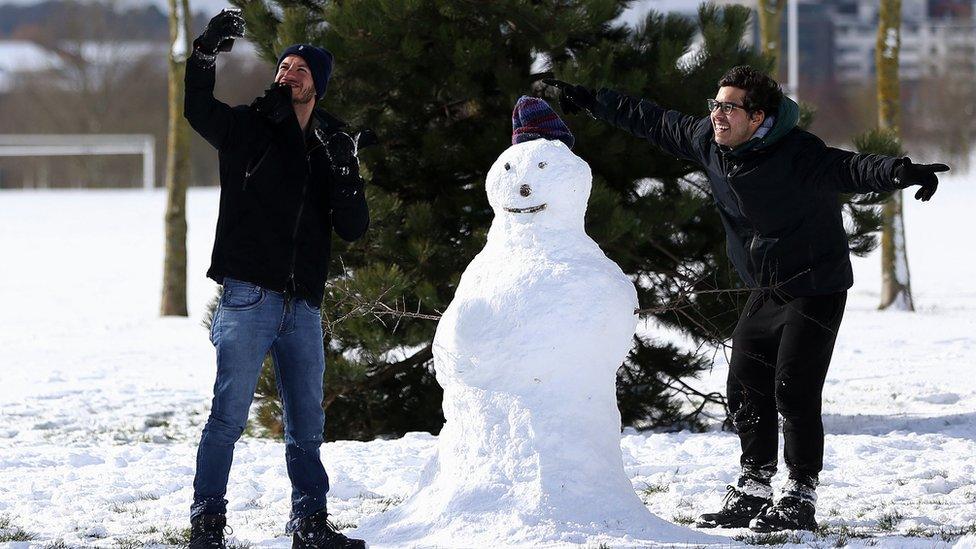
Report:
0,134,156,191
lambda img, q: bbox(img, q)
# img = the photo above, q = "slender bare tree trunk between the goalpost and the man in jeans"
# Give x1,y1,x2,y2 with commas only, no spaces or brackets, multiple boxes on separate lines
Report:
160,0,190,316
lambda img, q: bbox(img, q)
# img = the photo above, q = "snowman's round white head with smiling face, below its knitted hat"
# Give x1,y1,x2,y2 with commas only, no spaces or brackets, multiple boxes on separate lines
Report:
485,139,592,230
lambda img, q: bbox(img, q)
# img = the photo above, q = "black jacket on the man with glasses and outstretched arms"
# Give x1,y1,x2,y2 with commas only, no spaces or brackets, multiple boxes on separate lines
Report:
593,89,903,296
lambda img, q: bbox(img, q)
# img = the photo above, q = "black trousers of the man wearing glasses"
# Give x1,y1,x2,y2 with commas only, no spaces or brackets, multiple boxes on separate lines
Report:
727,291,847,485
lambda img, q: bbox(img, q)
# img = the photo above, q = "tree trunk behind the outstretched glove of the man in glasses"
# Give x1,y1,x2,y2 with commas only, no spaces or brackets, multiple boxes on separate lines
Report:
875,0,915,311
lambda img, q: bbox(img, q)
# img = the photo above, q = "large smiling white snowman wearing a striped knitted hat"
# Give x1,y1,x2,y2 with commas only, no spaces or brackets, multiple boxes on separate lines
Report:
356,96,716,547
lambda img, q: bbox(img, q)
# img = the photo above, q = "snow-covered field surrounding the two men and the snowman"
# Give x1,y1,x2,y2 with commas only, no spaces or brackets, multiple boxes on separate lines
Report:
0,170,976,548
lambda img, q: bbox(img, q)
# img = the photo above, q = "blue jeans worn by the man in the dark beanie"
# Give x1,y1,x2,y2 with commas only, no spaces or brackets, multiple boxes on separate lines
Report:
190,278,329,526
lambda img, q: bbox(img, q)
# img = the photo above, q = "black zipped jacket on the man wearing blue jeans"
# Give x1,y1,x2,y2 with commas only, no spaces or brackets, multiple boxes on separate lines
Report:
184,54,369,304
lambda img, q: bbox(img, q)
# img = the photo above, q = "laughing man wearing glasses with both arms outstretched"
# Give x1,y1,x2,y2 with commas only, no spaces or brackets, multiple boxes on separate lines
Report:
546,66,949,532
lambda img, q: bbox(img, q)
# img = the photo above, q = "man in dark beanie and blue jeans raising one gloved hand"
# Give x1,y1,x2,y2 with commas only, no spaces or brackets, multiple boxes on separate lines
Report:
184,10,369,549
